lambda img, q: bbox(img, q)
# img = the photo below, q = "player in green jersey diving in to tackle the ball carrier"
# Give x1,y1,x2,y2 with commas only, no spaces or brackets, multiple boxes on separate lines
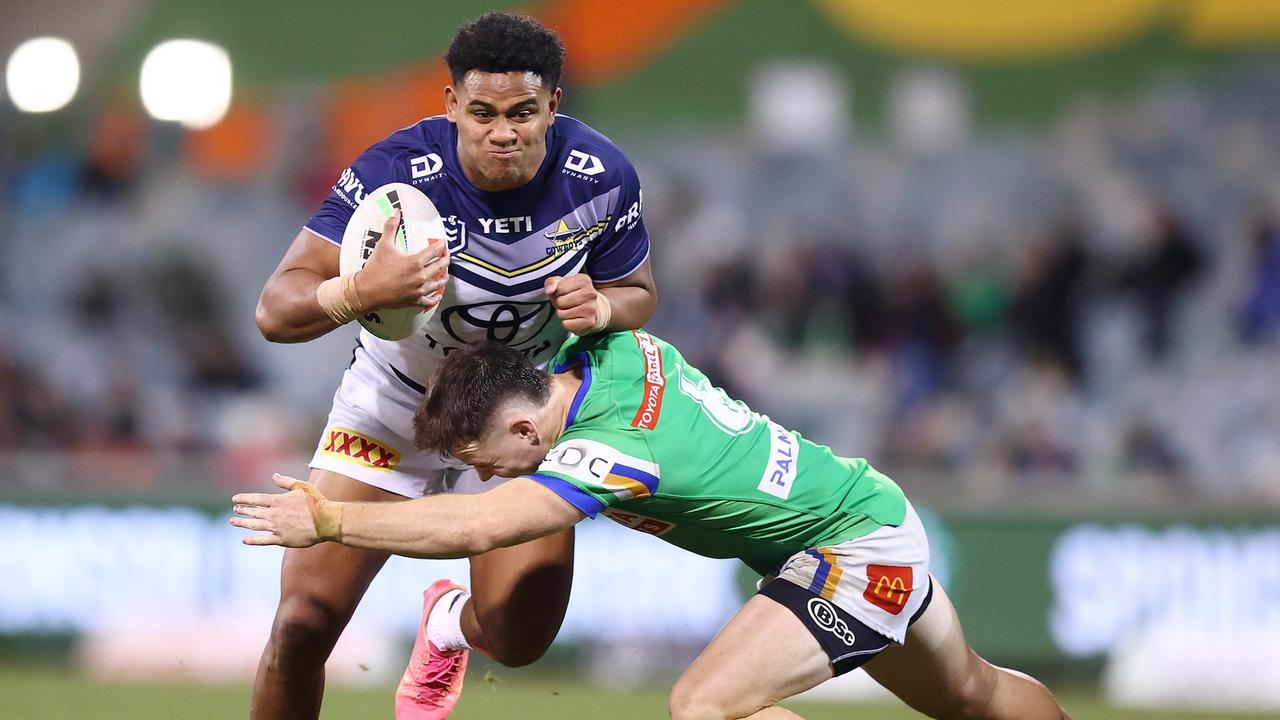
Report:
232,331,1066,720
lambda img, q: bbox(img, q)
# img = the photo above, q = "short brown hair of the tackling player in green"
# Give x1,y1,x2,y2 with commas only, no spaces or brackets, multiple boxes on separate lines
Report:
413,342,552,452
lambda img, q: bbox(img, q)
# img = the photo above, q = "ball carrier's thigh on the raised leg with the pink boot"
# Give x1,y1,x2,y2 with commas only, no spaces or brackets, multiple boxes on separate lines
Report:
471,528,573,625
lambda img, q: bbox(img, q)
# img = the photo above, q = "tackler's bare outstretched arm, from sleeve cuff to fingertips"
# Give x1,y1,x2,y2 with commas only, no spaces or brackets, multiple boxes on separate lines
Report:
230,475,585,557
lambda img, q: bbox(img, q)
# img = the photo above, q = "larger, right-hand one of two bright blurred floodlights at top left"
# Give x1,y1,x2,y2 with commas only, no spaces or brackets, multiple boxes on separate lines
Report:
140,40,232,129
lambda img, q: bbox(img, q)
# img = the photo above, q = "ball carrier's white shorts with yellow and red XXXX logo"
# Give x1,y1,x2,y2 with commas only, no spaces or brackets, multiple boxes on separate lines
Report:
310,343,503,497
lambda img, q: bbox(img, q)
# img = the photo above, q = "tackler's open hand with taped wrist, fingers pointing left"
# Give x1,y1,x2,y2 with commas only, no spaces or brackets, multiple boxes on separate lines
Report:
230,474,340,547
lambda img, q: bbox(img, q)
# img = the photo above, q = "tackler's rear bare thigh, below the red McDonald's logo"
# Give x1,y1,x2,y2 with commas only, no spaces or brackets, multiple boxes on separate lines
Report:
864,578,995,717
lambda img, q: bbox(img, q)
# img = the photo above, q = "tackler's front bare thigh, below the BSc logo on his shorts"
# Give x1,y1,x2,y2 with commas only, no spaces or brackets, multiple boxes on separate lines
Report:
671,594,832,717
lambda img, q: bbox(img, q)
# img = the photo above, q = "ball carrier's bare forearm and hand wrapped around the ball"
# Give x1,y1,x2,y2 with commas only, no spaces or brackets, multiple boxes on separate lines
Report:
255,214,449,342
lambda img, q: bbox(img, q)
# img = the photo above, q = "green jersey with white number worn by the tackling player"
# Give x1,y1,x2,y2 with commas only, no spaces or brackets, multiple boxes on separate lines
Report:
530,331,906,574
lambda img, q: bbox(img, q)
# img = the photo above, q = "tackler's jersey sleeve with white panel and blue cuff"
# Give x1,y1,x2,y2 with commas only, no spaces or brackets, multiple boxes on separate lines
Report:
527,433,660,518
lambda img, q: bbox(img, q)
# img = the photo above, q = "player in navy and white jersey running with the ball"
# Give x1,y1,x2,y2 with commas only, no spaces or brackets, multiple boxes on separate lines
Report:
251,13,655,720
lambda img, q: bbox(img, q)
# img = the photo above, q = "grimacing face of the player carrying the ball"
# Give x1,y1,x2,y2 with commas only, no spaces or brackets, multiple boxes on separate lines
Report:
444,70,559,191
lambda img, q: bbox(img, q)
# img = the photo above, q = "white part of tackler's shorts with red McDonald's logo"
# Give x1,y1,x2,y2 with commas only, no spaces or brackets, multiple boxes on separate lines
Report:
763,502,929,644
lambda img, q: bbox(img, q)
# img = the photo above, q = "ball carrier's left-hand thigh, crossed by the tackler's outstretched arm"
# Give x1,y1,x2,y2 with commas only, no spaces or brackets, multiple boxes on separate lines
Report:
273,469,404,629
